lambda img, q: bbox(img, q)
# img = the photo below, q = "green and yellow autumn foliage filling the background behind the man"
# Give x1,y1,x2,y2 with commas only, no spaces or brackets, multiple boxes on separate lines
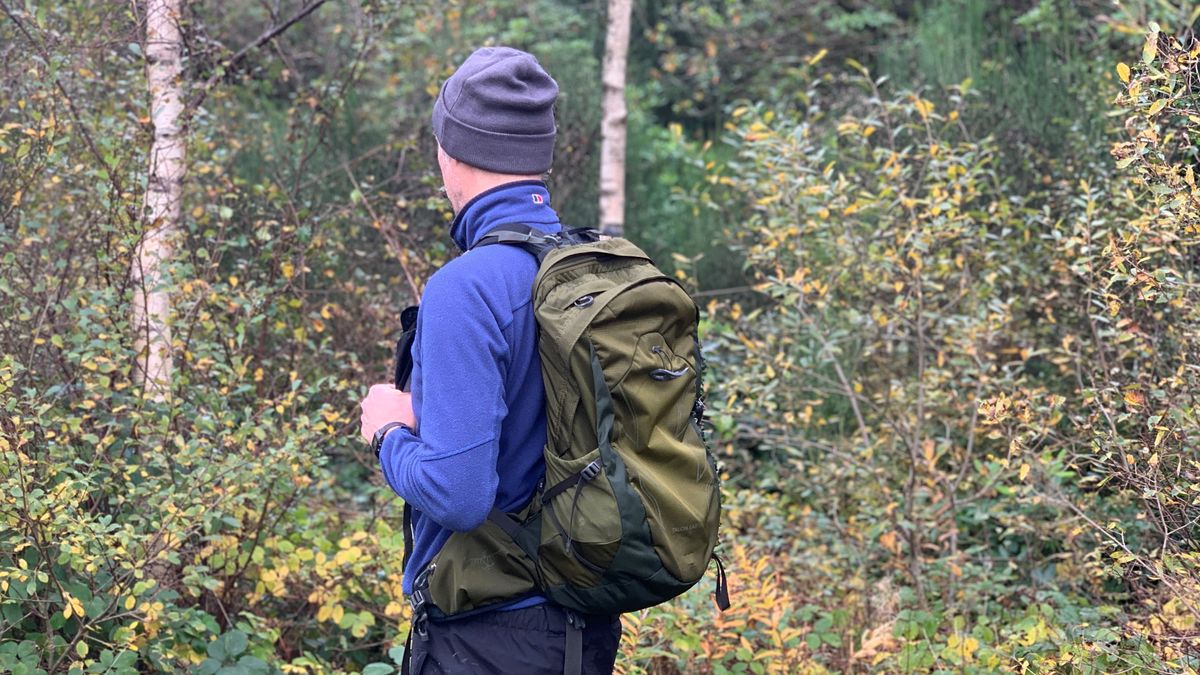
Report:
0,0,1200,674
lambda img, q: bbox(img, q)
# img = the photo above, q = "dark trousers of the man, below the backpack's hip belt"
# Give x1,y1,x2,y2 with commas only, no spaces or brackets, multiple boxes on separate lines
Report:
409,604,620,675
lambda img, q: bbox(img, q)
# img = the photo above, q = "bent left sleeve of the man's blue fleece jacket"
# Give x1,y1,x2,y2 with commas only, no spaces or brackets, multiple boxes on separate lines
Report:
379,269,511,532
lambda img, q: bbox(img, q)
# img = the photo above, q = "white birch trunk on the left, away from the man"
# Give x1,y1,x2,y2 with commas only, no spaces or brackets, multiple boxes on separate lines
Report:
133,0,186,400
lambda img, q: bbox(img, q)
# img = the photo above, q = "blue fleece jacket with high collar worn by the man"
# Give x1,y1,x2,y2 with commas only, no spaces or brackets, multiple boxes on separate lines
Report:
379,180,562,598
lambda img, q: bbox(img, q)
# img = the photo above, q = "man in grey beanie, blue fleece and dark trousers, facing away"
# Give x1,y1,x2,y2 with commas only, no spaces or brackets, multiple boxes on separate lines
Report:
361,47,620,674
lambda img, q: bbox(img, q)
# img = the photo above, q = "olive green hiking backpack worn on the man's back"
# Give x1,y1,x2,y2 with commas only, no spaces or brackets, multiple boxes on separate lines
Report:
410,226,728,634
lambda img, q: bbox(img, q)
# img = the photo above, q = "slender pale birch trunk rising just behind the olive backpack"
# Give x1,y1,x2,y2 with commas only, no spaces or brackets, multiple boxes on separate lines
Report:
600,0,632,237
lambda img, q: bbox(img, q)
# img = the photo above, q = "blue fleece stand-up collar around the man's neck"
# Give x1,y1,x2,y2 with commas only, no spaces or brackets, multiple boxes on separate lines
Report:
450,180,559,251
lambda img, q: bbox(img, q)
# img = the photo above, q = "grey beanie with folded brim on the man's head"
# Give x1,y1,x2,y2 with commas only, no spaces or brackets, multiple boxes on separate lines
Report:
433,47,558,174
